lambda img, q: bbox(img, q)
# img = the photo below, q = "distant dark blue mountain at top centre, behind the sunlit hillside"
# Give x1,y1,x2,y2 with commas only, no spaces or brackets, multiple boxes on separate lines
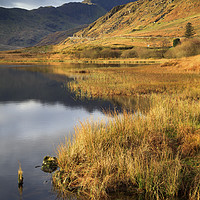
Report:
83,0,137,11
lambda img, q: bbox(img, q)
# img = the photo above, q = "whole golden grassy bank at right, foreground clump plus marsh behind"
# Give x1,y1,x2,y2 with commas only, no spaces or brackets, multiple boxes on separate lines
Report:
53,63,200,200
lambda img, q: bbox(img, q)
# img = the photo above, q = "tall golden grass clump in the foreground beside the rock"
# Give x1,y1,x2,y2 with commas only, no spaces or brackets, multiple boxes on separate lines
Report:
53,95,200,199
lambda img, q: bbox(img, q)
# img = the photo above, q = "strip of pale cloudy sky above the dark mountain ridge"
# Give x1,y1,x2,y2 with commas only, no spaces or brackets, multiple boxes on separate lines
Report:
0,0,82,10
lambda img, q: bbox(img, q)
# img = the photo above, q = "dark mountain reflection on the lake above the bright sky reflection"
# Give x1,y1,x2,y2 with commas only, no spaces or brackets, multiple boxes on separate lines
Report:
0,68,117,112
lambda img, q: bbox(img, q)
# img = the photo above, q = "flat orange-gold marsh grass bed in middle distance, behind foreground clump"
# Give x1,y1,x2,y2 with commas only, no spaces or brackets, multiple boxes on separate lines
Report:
68,66,200,100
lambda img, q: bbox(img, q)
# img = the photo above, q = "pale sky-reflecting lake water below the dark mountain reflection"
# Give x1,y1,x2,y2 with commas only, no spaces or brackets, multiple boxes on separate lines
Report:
0,100,106,200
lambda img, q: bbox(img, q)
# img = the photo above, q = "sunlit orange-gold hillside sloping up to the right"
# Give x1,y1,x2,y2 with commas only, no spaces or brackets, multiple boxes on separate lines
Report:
49,0,200,57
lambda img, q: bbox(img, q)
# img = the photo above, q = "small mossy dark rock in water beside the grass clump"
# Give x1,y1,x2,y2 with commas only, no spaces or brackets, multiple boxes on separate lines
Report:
41,156,58,173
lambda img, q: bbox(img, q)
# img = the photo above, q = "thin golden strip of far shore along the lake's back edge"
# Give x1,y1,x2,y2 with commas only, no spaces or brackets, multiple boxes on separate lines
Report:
0,55,200,72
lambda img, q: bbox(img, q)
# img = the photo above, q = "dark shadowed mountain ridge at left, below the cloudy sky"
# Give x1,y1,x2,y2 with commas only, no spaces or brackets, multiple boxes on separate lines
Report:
0,3,106,48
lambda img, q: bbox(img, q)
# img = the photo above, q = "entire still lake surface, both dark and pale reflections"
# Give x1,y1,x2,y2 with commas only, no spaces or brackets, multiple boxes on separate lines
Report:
0,65,117,200
